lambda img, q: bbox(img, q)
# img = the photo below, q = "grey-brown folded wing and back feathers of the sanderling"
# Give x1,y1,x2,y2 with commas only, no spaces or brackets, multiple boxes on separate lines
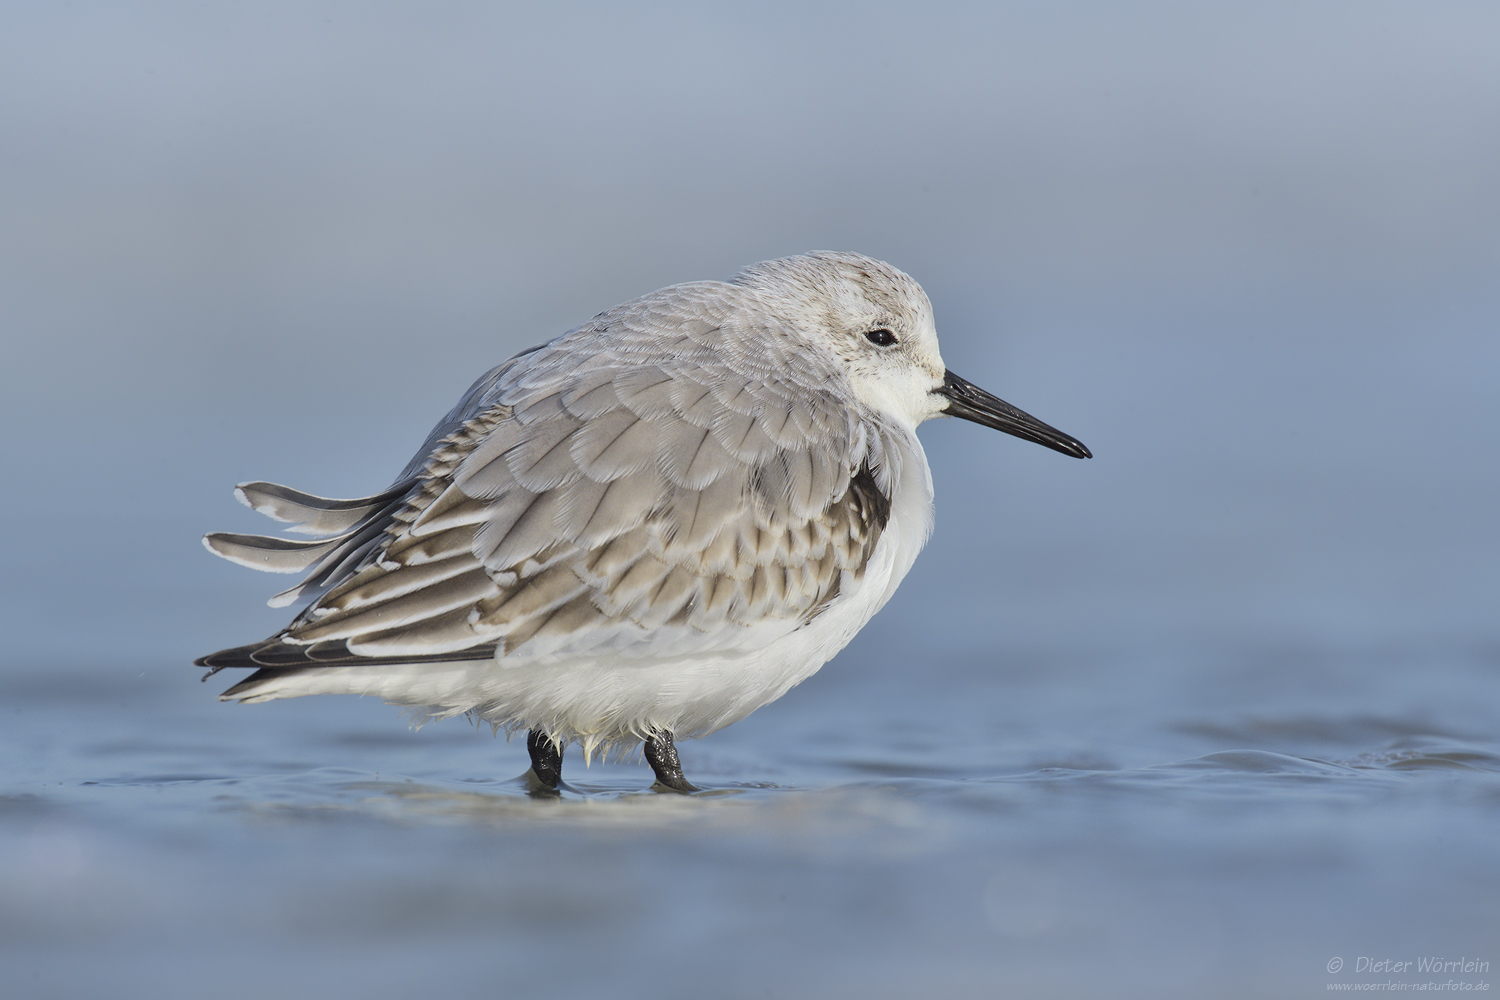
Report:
203,286,900,667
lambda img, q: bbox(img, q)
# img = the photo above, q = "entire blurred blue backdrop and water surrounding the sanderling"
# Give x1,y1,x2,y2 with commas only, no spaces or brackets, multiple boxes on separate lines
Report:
0,1,1500,997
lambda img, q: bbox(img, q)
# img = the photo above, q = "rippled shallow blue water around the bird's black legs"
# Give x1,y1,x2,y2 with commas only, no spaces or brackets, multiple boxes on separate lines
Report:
0,642,1500,997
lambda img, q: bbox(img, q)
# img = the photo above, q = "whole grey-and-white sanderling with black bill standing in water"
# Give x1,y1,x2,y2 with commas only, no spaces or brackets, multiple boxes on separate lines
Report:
197,253,1091,792
